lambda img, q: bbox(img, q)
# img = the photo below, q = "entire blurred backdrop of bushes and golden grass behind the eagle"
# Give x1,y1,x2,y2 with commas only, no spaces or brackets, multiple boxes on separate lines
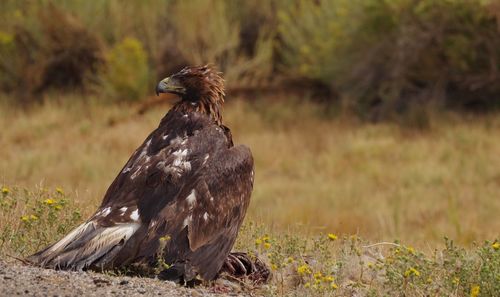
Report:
0,0,500,245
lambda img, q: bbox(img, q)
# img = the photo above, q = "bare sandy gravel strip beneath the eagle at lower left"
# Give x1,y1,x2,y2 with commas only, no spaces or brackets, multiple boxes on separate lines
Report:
0,260,245,297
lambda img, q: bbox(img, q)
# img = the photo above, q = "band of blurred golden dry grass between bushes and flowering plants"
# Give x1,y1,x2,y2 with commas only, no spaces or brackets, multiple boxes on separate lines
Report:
0,97,500,246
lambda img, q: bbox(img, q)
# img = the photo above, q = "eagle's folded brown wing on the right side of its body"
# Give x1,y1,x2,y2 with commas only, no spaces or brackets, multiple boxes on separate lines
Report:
136,141,253,279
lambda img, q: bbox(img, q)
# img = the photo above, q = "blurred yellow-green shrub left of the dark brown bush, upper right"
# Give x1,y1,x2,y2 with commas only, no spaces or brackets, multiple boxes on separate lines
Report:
277,0,360,84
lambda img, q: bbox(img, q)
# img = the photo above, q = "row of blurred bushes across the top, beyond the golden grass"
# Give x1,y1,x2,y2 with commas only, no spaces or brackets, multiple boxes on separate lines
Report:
0,0,500,120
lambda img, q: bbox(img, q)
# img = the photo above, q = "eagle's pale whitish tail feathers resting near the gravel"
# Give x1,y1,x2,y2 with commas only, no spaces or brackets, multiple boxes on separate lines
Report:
28,221,140,270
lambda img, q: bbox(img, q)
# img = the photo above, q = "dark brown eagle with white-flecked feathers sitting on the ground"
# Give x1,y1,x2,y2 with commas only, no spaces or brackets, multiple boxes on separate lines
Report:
28,65,254,282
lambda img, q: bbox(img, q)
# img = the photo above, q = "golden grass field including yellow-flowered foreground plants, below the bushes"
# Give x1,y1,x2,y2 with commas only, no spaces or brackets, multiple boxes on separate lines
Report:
0,95,500,296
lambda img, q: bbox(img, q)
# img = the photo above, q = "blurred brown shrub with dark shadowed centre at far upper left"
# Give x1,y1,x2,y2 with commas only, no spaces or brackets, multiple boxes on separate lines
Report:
0,5,102,98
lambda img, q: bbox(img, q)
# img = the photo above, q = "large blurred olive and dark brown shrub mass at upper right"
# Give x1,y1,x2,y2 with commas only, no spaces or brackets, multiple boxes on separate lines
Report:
279,0,500,121
